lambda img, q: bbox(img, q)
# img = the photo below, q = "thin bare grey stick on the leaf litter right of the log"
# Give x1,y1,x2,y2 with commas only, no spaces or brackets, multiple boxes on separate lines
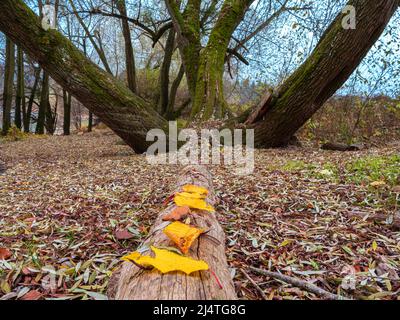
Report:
250,267,351,300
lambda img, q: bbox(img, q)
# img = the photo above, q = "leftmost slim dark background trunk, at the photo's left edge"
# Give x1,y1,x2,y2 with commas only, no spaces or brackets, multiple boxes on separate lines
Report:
2,37,15,135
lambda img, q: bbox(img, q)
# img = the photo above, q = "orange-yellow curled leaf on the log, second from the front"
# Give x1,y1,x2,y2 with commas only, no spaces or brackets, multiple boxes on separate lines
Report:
164,221,204,254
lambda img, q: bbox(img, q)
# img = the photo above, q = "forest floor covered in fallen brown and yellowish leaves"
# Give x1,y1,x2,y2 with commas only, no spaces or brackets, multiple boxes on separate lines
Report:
0,132,400,299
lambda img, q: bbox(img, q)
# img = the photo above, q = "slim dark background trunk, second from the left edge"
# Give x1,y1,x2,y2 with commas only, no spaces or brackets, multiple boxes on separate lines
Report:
14,47,26,130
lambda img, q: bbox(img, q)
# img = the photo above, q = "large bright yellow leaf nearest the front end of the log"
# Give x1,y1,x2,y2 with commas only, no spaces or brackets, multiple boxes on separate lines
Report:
122,246,208,274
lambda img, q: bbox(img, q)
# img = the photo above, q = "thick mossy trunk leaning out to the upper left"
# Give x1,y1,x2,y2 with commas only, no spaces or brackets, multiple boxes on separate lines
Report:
0,0,167,152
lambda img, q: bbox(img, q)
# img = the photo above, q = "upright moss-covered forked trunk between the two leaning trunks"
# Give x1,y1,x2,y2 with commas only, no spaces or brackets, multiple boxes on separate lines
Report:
166,0,254,120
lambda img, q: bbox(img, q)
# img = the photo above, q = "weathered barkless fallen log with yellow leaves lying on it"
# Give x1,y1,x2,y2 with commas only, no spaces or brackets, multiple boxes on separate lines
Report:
107,166,237,300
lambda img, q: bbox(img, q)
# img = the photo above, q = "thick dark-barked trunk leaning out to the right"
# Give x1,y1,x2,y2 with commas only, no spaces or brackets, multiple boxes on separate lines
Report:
247,0,399,147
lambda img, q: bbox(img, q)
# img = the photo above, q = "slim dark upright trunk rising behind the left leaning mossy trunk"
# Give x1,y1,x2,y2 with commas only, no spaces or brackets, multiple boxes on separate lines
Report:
116,0,137,93
